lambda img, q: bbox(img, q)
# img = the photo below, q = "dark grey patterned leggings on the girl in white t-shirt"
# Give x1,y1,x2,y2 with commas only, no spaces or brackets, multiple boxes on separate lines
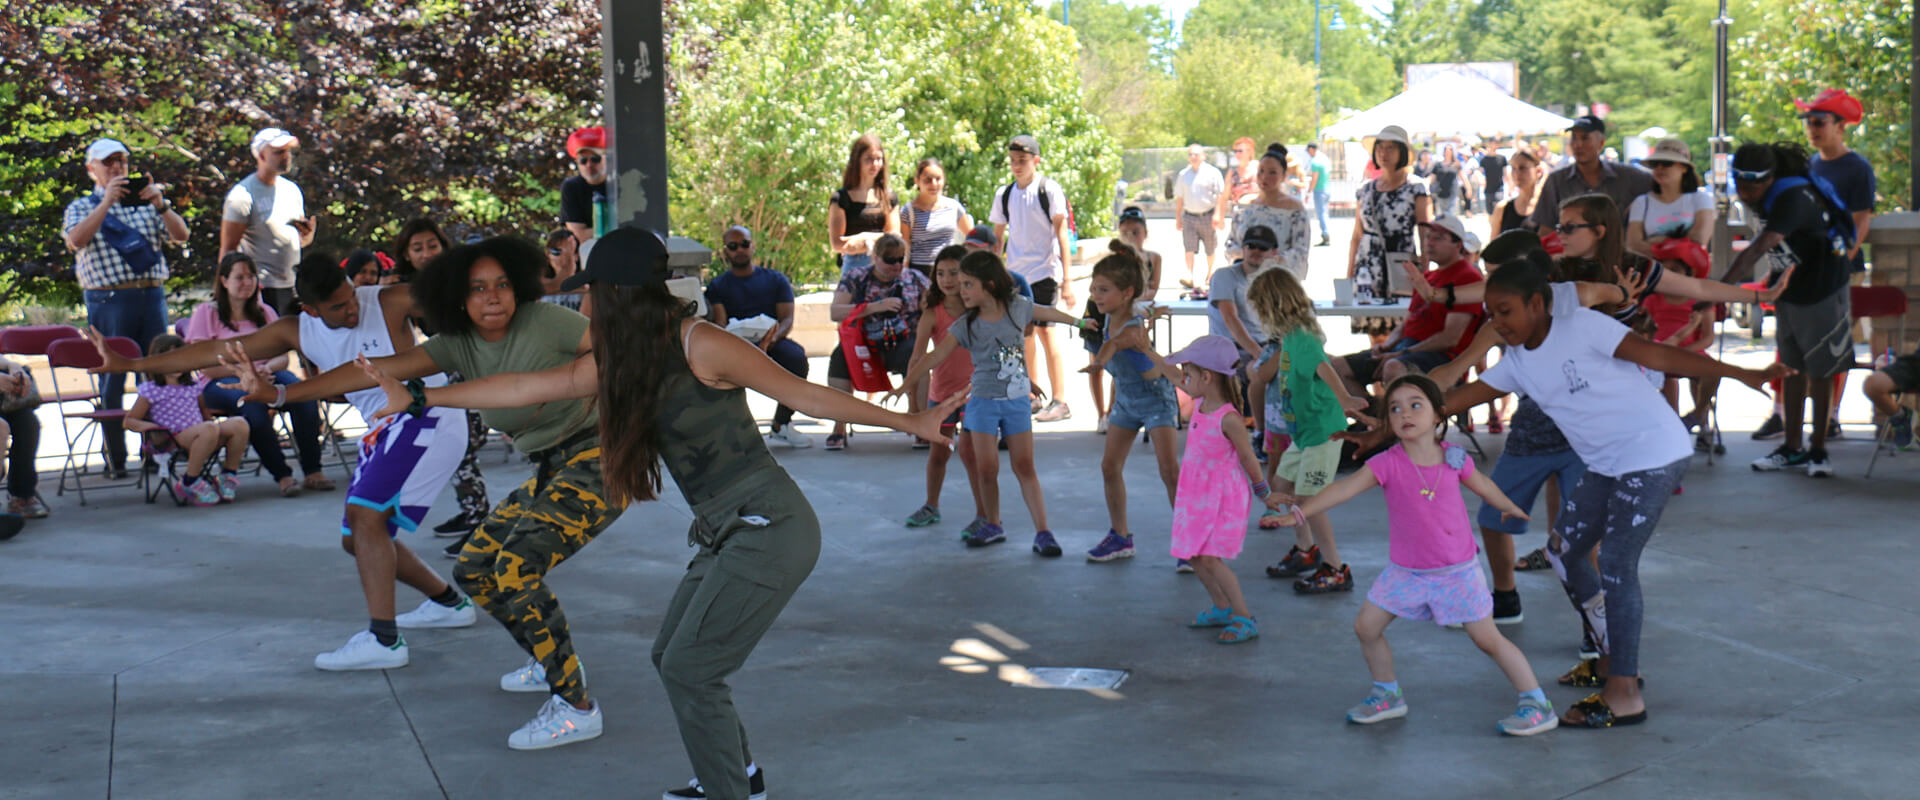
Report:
1557,459,1688,677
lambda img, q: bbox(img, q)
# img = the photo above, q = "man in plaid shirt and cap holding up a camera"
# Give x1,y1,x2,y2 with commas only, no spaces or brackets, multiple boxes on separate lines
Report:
63,138,186,478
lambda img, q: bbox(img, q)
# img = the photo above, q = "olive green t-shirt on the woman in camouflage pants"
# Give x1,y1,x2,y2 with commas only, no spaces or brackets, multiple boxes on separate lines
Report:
420,303,599,453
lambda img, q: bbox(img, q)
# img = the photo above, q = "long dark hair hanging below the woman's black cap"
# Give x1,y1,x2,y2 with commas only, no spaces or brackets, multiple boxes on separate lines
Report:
588,280,695,506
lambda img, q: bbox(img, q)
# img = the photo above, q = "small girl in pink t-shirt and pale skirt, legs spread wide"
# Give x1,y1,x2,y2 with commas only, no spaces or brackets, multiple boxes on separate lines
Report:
1275,374,1559,737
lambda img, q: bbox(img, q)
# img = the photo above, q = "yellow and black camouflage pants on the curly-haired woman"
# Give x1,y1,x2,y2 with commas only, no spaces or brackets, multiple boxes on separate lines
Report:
453,429,626,704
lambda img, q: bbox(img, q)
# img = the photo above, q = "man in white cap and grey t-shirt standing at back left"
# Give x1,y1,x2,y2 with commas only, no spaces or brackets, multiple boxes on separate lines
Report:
219,129,313,317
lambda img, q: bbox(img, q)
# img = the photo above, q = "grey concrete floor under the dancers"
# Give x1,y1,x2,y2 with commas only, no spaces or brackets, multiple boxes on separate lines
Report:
0,214,1920,800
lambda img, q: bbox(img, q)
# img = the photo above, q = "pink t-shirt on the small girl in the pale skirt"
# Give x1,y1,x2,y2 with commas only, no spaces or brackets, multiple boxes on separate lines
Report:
1367,445,1478,570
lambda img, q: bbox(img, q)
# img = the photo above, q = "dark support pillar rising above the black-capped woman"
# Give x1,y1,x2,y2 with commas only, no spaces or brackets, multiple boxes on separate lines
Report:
601,0,666,234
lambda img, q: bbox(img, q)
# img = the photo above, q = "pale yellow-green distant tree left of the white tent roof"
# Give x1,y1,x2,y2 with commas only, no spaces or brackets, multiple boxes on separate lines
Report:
1167,36,1313,146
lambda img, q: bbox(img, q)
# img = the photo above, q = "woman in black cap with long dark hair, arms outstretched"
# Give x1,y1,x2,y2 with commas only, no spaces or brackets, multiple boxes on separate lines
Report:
369,228,968,798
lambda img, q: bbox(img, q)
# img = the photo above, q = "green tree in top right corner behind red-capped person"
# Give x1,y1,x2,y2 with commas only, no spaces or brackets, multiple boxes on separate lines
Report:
1730,0,1914,211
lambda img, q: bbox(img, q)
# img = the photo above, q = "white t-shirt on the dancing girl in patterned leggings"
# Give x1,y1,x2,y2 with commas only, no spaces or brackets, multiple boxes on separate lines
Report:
1480,295,1693,478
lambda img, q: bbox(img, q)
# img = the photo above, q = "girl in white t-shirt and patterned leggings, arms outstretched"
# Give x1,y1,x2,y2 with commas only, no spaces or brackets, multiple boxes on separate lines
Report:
1448,261,1791,727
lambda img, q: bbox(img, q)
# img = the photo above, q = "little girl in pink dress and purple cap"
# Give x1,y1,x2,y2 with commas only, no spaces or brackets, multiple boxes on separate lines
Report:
1142,336,1281,645
